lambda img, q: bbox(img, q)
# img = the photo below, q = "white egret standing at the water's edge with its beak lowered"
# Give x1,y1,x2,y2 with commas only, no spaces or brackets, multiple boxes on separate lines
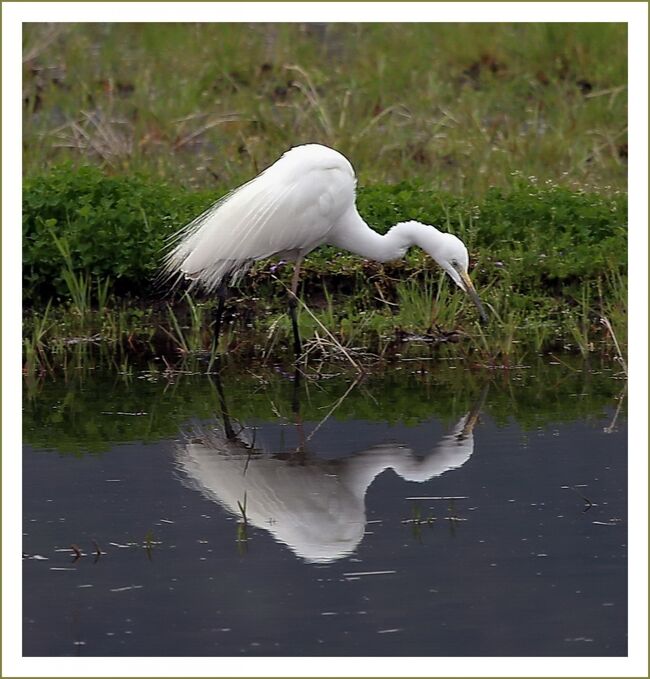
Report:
164,144,487,355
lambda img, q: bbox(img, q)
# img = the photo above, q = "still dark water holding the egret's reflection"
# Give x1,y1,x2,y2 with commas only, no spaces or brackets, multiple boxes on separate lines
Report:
23,361,627,656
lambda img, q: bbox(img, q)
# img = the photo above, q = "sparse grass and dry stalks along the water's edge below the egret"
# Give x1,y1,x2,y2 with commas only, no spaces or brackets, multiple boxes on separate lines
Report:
23,262,627,380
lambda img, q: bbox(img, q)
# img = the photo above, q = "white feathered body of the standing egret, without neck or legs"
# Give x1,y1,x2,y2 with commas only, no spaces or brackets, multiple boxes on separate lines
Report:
165,144,356,290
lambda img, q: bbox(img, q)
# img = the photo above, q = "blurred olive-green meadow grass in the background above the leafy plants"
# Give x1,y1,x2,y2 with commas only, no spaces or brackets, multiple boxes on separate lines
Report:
23,23,627,196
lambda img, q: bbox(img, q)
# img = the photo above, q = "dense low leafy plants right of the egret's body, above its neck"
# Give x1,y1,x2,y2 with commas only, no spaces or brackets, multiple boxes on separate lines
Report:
359,179,627,293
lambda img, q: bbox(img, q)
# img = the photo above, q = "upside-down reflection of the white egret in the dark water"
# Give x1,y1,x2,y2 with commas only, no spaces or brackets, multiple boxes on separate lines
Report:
176,384,485,563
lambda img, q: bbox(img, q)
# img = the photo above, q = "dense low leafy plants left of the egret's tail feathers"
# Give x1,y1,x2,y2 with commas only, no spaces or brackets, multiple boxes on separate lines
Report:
23,165,216,303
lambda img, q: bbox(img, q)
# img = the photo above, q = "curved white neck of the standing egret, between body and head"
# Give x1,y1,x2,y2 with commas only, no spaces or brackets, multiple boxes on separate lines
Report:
327,208,442,262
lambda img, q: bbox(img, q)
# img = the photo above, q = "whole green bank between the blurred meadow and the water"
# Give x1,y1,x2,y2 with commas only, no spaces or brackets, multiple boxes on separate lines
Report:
23,166,627,378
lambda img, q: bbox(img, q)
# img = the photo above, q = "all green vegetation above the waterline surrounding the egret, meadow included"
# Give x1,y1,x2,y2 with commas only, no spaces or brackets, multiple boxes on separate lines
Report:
23,24,627,372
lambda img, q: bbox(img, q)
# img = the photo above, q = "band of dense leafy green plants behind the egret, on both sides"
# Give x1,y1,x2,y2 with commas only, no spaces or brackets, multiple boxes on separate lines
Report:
23,165,627,306
